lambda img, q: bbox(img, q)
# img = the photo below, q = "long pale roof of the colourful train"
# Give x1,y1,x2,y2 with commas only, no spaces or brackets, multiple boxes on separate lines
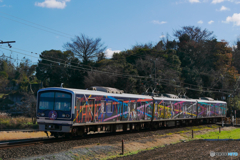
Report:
38,87,226,103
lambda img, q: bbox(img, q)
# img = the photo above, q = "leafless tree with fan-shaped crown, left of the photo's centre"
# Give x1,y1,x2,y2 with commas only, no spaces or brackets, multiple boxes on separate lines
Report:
64,34,106,63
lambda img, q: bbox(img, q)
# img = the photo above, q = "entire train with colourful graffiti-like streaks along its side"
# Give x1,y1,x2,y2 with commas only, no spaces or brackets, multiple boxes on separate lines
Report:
36,87,227,137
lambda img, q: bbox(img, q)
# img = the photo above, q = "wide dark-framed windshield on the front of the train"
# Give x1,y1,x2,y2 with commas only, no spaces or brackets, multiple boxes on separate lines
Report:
39,92,72,111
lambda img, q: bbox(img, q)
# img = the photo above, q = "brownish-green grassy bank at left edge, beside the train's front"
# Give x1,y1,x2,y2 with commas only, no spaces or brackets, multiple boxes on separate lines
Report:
0,113,38,130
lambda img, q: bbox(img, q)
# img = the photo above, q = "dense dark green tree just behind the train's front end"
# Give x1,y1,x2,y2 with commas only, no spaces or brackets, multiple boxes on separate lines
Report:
36,50,85,88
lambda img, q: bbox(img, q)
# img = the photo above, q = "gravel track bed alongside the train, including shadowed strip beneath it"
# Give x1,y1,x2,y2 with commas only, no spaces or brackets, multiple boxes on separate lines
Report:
0,124,219,159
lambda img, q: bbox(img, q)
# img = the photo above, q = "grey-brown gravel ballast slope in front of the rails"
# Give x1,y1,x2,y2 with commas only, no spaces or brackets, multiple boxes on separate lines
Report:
0,125,218,160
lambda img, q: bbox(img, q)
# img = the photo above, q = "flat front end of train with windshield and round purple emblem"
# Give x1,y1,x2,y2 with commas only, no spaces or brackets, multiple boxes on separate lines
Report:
37,88,74,137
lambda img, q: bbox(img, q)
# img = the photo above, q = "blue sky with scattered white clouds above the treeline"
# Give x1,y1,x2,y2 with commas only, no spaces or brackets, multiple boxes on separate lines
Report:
0,0,240,63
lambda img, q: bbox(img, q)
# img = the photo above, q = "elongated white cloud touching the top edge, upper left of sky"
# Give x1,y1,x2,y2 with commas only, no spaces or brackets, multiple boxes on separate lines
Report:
35,0,71,9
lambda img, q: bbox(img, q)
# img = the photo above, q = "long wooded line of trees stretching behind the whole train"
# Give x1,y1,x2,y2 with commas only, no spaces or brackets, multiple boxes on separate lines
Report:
0,26,240,117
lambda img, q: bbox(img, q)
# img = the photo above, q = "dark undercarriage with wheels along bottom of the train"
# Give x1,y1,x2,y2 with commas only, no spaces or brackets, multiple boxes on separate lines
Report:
45,117,223,138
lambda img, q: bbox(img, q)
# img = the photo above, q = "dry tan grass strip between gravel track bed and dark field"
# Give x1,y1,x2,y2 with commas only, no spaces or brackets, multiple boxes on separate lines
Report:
71,125,227,160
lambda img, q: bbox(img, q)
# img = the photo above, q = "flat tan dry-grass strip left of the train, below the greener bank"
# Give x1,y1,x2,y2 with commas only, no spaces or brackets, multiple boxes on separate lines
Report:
0,131,50,141
